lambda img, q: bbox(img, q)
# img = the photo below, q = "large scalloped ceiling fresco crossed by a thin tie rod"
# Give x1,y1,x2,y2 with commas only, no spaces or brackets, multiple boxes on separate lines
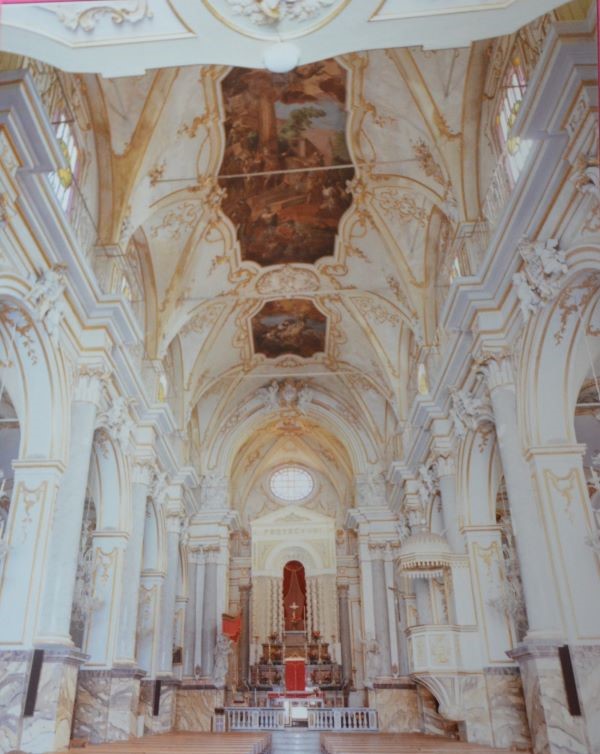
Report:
219,60,354,266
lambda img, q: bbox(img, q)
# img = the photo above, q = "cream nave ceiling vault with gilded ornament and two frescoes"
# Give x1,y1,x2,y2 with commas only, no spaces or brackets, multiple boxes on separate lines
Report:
77,43,489,482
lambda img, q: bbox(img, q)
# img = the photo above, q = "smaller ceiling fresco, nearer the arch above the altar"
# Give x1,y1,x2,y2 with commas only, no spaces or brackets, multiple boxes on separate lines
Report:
252,299,327,358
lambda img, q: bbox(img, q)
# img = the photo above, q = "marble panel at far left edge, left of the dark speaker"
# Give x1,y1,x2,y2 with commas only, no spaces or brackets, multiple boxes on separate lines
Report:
0,651,31,751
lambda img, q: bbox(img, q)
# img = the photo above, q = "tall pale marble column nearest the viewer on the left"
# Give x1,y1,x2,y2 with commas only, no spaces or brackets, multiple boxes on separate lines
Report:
39,369,102,645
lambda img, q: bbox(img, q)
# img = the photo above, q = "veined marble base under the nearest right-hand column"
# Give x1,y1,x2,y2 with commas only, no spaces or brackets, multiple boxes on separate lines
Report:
507,641,598,754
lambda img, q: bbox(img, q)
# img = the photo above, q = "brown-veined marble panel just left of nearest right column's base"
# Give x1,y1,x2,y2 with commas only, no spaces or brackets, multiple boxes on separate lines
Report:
484,668,531,749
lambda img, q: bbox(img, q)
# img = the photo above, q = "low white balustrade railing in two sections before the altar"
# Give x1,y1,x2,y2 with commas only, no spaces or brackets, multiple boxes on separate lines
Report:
225,707,379,732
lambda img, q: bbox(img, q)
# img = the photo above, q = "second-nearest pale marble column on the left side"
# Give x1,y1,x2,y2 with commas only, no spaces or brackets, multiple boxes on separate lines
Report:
115,459,154,666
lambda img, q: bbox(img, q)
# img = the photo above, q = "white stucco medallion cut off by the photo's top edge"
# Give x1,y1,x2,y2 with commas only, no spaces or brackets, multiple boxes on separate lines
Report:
204,0,349,39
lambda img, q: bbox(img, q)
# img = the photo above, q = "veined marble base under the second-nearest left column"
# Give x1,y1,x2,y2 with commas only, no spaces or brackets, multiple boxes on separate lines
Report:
73,667,145,744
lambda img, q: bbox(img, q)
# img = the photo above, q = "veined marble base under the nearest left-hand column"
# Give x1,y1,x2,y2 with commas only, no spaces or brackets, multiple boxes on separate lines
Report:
16,646,87,754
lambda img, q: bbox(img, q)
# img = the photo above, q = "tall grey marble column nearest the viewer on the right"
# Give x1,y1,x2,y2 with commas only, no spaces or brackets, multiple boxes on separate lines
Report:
482,356,561,638
